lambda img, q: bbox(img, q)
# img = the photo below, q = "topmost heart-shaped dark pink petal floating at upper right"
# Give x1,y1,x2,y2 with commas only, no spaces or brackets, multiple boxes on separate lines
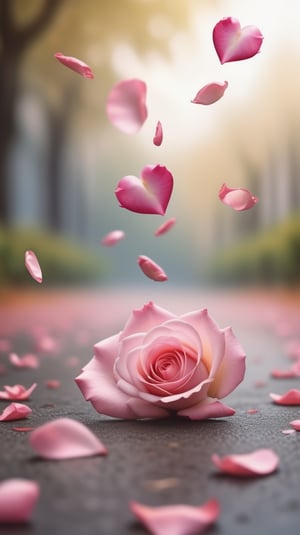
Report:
213,17,263,64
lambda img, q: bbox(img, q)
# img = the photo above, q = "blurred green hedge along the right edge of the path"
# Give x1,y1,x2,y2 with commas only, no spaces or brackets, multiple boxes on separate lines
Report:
209,216,300,285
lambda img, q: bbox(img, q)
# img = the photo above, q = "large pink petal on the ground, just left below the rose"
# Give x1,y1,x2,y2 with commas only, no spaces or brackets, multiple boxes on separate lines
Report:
29,418,107,460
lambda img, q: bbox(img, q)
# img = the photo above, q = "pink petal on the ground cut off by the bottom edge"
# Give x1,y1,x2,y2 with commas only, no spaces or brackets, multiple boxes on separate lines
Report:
129,500,220,535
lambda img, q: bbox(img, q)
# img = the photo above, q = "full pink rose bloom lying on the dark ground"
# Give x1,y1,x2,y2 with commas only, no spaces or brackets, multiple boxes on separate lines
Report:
75,302,245,420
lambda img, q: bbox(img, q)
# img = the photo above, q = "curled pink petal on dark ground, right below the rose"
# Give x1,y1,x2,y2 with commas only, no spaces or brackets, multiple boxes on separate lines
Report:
211,449,279,476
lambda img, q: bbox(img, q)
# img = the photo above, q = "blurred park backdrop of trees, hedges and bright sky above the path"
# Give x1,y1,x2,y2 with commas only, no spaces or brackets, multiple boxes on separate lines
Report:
0,0,300,287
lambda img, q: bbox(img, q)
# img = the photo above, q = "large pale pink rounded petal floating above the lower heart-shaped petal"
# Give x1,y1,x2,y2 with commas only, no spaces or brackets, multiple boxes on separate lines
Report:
106,79,148,134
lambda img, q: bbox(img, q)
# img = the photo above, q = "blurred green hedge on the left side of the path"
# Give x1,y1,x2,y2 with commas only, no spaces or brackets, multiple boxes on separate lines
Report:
0,229,105,286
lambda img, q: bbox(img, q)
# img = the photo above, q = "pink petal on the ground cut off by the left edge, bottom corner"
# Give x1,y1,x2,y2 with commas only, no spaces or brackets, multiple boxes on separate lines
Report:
0,479,40,524
